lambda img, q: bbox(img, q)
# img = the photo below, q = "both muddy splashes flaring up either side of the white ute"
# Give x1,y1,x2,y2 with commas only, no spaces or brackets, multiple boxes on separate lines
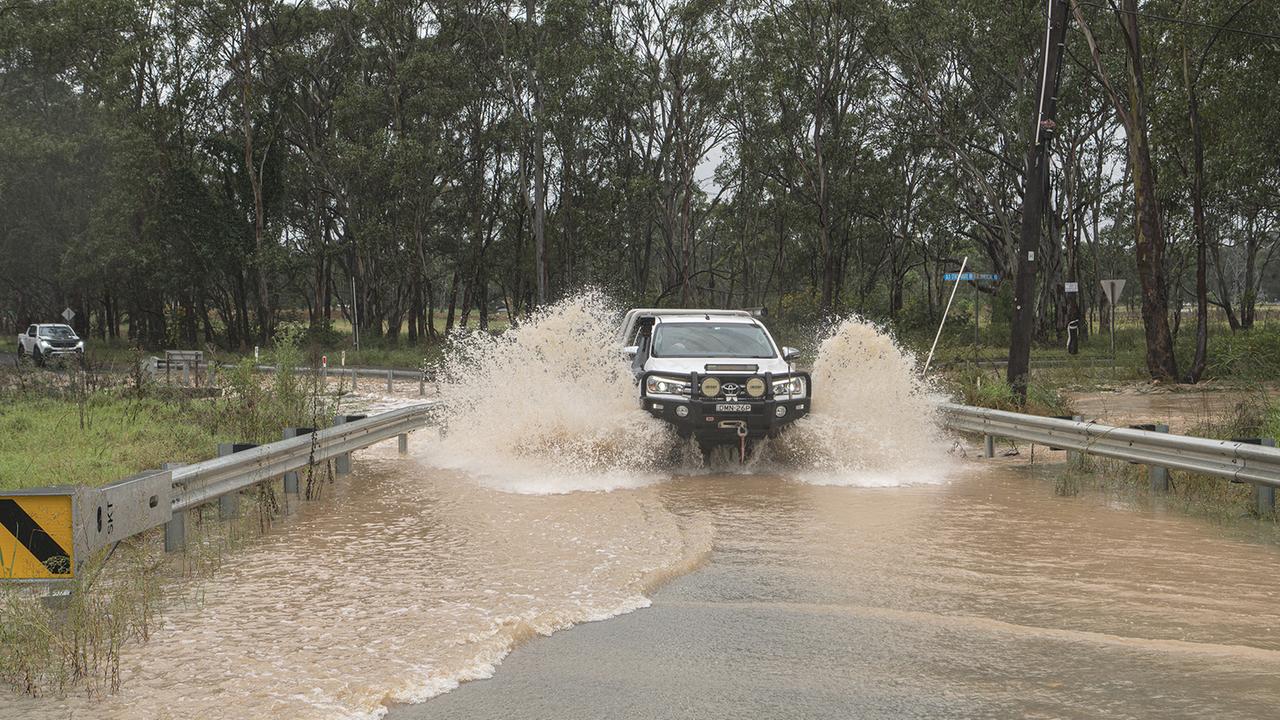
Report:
429,292,948,493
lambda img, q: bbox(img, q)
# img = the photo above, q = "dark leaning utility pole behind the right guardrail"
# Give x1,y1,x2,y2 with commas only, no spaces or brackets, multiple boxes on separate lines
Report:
1007,0,1066,402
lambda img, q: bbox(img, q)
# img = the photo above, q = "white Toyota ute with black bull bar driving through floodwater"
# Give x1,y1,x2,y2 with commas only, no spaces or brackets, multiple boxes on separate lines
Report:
618,309,813,455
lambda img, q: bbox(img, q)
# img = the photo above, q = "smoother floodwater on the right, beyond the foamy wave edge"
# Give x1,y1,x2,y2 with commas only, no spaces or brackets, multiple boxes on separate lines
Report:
404,462,1280,720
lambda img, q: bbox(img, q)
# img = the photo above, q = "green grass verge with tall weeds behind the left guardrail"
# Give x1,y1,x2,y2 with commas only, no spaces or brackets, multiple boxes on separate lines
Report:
0,327,338,489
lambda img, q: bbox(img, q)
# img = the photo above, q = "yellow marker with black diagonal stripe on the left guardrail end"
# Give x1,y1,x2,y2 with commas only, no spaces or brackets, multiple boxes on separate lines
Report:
0,495,76,580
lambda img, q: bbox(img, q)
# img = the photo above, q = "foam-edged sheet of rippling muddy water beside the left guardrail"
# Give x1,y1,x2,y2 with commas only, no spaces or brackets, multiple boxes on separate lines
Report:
0,433,710,720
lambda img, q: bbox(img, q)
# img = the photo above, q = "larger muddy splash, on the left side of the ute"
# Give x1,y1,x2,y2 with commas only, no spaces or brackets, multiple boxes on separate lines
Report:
428,292,675,493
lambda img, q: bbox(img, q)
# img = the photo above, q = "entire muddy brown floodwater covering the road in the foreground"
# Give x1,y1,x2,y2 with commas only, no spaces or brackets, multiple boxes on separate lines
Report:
0,438,1280,720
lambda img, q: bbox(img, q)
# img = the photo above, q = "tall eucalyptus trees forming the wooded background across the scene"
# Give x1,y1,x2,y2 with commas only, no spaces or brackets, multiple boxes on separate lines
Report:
0,0,1280,368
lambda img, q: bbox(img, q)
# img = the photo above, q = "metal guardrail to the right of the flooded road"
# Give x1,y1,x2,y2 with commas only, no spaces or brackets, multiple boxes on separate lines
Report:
941,402,1280,512
